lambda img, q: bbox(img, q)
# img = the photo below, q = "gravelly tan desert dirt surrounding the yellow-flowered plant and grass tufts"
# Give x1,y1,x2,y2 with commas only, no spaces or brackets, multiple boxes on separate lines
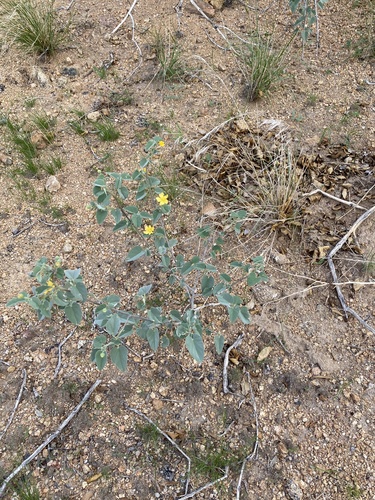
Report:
0,0,375,500
